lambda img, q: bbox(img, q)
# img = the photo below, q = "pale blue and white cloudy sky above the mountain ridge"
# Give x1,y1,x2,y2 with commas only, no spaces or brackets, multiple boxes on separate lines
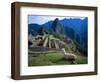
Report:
28,15,85,25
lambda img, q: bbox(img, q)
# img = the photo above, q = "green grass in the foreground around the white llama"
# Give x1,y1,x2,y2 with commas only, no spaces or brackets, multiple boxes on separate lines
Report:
28,52,87,66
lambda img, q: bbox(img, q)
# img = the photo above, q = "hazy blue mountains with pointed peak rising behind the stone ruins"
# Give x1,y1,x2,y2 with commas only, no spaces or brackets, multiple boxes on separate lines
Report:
28,17,88,48
